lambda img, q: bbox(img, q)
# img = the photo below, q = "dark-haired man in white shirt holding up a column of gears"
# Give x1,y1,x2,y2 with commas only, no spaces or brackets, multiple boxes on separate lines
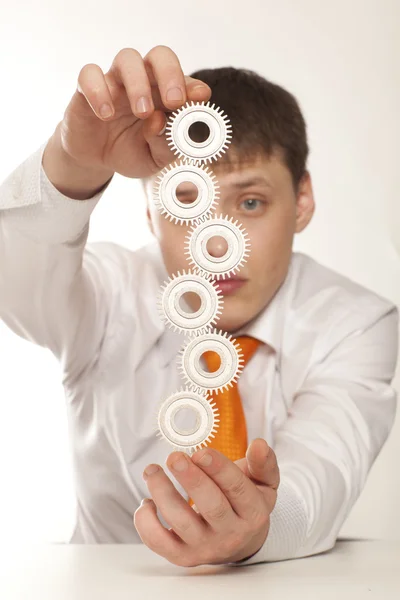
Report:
0,46,397,566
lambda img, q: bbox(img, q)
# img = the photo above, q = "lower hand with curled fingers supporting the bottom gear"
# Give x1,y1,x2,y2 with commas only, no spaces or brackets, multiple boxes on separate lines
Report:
134,438,279,567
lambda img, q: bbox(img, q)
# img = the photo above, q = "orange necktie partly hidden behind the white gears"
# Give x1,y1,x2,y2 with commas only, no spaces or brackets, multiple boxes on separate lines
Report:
189,336,261,506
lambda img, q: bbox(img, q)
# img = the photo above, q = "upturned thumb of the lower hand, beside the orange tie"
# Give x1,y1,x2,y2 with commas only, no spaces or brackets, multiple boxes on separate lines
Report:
246,438,279,490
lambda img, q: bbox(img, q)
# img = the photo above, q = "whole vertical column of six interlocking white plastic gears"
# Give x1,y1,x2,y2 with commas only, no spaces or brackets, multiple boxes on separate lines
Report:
154,102,250,454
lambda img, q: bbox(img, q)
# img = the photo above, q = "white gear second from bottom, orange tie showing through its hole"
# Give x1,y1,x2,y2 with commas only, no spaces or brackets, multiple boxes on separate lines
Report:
179,330,244,394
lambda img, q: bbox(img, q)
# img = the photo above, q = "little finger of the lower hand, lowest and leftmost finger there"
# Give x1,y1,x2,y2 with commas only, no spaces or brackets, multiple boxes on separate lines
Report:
133,494,186,561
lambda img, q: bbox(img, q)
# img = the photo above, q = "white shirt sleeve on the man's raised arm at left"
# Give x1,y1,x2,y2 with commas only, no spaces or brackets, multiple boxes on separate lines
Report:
0,142,115,390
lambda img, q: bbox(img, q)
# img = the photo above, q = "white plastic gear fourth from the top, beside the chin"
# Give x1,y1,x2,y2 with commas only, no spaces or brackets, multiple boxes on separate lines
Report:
157,271,223,334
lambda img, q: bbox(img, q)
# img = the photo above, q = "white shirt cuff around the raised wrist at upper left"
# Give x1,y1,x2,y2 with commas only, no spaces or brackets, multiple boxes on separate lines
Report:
0,141,111,244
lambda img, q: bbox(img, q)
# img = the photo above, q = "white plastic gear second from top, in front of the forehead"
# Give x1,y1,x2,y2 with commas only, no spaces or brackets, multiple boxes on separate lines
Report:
153,161,219,225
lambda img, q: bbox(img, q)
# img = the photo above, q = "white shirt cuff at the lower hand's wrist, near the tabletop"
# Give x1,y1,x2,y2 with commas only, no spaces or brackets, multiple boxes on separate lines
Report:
227,480,308,567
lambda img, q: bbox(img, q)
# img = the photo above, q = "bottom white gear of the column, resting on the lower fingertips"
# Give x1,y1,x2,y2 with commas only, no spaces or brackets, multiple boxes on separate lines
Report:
156,389,219,454
